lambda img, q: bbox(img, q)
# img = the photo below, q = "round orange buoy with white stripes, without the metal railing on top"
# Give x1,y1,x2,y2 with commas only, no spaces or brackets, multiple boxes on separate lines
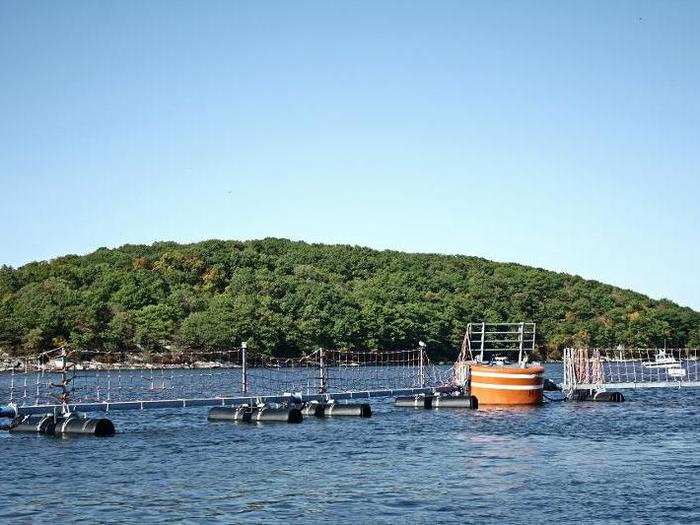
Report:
469,365,544,405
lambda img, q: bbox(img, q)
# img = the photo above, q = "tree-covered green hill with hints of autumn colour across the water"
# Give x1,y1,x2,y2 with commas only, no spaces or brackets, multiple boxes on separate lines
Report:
0,239,700,357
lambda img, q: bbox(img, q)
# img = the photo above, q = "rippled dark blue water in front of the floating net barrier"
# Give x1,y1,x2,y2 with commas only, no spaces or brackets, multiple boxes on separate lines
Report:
0,365,700,524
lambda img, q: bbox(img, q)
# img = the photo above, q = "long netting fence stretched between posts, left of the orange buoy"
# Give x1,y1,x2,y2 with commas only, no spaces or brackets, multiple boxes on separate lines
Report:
0,348,444,407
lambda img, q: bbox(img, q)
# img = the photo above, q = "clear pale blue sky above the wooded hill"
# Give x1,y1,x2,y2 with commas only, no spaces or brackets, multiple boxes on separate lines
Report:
0,0,700,309
